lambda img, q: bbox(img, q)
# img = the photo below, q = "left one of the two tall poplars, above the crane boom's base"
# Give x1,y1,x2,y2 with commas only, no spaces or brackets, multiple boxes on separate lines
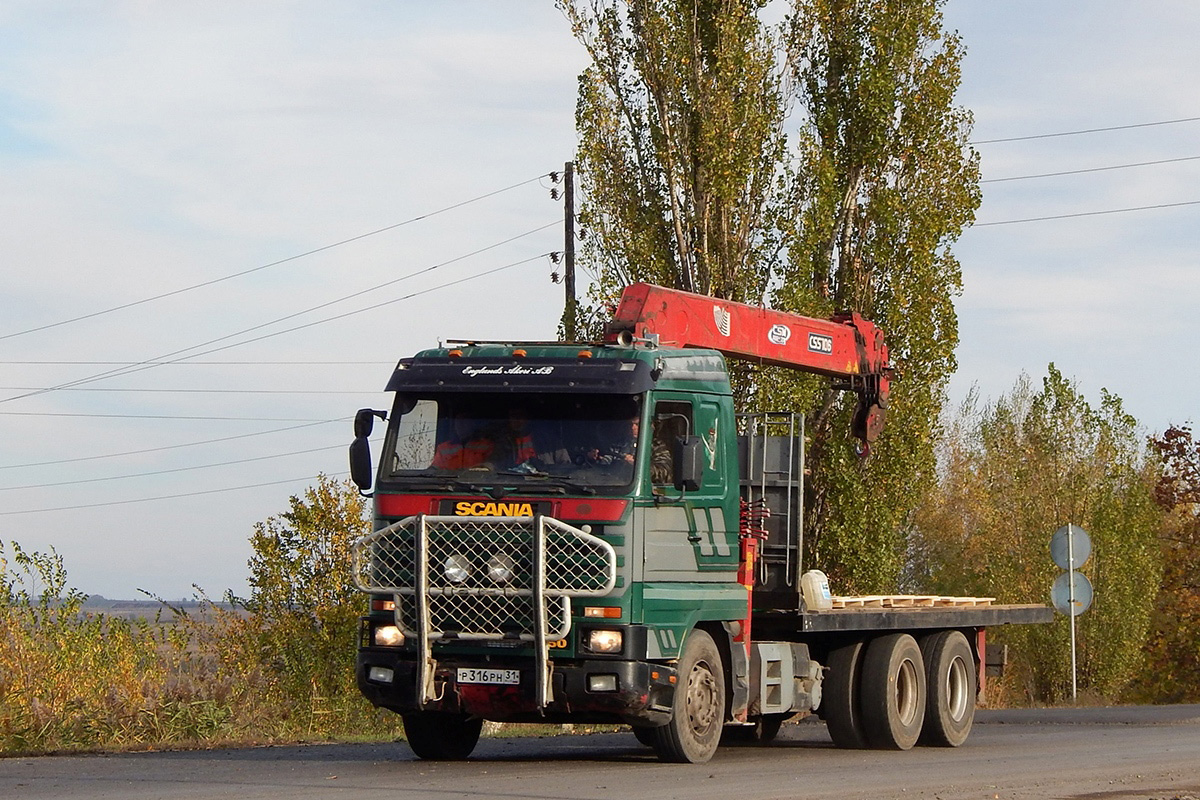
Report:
559,0,785,327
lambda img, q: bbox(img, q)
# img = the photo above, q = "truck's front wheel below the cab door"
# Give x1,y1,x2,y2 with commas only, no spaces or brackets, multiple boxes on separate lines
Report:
653,628,725,764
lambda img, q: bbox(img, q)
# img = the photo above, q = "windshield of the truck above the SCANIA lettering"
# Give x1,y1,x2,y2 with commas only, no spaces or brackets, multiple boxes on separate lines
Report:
383,392,641,492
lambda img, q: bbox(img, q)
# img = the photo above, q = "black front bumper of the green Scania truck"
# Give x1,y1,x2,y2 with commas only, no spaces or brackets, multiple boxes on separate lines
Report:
355,648,677,727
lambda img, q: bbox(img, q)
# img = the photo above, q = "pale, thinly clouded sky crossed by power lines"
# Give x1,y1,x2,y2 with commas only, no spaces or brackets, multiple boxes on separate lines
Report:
0,0,1200,599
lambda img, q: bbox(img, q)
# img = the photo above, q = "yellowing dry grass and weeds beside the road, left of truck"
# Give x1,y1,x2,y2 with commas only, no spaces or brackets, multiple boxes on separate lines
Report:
0,543,400,754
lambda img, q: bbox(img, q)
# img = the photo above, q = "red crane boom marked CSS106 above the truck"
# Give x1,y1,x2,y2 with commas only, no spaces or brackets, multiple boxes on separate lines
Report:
605,283,893,443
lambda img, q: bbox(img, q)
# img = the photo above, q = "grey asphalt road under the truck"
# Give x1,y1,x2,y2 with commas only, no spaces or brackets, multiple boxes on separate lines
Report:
0,705,1200,800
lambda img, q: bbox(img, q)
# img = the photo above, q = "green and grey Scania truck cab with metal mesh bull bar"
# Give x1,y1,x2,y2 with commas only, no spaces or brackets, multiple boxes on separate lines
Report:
356,343,750,762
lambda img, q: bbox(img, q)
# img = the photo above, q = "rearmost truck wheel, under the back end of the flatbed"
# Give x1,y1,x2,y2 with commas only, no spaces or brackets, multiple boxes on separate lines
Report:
920,631,978,747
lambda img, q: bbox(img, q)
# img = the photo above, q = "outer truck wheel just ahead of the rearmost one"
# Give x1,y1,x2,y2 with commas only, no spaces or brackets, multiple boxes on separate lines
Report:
859,633,925,750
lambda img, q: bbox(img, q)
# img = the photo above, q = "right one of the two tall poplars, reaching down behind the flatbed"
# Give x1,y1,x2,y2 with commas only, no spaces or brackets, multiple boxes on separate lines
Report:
758,0,980,593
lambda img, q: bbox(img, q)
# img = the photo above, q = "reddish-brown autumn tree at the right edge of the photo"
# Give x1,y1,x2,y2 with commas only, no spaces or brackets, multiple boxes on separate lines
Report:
1135,426,1200,703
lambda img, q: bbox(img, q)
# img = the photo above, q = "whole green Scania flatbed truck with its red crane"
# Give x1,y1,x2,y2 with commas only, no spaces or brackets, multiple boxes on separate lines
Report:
350,284,1051,763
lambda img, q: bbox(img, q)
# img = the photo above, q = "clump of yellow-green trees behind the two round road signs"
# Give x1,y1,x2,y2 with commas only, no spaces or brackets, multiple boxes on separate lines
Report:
910,365,1162,702
